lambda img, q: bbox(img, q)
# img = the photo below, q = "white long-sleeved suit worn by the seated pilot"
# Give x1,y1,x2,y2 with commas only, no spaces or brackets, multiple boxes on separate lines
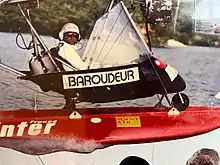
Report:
58,42,89,71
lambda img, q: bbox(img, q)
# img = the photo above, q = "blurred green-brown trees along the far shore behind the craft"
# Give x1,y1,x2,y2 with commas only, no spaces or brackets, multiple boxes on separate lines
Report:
0,0,219,47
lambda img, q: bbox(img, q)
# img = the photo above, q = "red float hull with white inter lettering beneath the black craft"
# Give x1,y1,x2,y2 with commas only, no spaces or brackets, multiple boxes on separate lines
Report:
0,107,220,155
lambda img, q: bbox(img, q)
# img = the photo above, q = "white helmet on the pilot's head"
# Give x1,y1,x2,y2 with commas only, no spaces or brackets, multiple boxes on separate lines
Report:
59,23,81,40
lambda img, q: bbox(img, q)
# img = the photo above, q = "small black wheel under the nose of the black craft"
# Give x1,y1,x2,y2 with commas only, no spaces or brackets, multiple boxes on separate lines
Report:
172,93,189,111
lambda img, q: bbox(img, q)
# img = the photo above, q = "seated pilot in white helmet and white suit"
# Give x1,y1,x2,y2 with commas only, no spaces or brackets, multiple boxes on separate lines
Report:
58,23,89,71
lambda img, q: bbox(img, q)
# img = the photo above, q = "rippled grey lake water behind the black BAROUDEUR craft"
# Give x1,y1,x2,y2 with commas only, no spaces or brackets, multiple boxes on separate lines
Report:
0,33,220,109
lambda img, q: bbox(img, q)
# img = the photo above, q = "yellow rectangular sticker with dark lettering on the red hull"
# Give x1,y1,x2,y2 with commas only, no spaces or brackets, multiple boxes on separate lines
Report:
116,116,141,127
